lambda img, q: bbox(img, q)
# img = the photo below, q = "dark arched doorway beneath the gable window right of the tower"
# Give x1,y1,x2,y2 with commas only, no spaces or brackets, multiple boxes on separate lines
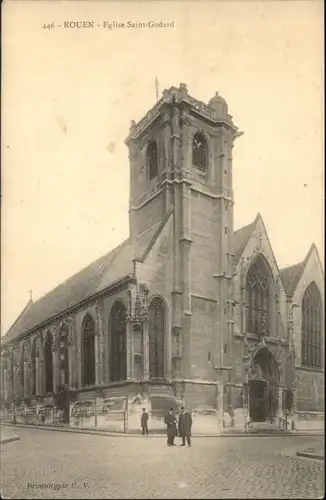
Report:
248,348,279,422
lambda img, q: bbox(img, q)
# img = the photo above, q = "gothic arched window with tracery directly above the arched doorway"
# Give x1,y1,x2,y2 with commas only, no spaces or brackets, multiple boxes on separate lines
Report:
246,256,270,335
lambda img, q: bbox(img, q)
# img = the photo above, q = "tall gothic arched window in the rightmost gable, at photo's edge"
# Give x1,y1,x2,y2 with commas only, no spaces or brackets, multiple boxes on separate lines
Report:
301,282,322,368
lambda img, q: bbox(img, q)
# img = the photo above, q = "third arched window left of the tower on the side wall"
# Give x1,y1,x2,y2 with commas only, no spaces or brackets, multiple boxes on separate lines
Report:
82,314,95,386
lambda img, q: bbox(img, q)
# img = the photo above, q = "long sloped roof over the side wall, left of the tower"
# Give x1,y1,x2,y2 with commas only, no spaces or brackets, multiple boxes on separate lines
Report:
1,220,166,344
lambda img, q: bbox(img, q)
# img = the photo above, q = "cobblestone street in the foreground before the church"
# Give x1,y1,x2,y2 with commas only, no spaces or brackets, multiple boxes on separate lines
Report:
1,428,324,498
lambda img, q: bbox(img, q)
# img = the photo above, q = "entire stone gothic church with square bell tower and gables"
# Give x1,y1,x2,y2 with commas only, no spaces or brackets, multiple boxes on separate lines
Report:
1,84,324,433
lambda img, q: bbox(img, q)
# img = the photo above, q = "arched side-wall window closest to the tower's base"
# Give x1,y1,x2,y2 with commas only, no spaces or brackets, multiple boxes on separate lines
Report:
148,297,165,378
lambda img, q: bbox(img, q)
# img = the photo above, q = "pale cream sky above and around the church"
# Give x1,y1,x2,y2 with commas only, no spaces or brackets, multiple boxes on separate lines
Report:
1,0,324,335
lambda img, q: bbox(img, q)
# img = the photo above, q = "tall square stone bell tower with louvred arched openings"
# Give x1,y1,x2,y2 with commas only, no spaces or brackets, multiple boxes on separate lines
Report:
126,84,242,386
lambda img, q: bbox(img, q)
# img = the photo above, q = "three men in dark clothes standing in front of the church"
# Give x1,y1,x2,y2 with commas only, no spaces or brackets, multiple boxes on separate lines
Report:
141,406,192,446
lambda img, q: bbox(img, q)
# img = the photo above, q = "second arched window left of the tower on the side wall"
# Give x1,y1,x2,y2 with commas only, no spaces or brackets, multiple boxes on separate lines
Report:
109,301,127,382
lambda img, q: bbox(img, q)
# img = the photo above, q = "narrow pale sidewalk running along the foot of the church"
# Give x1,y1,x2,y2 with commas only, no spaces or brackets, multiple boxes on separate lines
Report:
3,422,324,438
